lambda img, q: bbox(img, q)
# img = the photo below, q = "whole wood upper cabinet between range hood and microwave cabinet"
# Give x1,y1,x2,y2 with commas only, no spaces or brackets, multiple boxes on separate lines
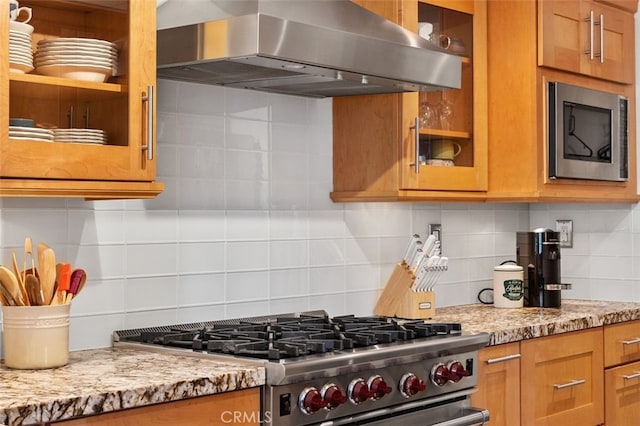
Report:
331,0,487,201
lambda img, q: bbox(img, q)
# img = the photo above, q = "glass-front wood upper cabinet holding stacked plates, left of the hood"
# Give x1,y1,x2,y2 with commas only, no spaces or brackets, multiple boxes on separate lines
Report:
0,0,163,199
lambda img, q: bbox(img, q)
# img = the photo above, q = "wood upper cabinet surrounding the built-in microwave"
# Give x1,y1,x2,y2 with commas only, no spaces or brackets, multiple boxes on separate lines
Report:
487,0,639,203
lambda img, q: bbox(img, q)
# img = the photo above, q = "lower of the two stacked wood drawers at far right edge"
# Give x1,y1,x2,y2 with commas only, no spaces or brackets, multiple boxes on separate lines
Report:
604,362,640,425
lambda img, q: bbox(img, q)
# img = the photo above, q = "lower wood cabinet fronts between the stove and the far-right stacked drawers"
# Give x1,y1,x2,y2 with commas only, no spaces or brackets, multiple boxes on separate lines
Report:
472,327,604,426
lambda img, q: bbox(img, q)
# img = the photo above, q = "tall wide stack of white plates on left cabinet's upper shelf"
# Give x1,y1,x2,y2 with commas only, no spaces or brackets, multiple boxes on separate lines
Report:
35,38,118,82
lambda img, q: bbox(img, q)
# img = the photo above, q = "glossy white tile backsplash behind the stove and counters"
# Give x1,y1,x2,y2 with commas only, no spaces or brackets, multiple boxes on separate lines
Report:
0,80,640,349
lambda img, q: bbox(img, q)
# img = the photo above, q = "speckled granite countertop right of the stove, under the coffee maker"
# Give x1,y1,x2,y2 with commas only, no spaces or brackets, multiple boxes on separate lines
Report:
428,300,640,345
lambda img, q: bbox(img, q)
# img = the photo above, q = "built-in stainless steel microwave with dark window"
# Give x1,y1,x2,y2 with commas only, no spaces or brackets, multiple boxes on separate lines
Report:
547,82,629,181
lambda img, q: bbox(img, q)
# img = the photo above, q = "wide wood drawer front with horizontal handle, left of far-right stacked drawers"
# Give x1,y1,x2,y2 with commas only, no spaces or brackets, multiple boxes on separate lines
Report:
520,328,604,426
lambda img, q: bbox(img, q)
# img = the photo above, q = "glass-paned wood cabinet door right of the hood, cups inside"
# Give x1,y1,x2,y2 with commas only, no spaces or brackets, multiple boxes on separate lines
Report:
403,1,487,191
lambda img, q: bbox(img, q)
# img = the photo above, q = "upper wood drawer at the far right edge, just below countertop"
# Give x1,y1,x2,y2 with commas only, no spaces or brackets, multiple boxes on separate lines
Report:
604,320,640,367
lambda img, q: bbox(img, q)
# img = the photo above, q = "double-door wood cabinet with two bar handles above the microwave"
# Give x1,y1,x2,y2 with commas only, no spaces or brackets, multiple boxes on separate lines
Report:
538,0,635,84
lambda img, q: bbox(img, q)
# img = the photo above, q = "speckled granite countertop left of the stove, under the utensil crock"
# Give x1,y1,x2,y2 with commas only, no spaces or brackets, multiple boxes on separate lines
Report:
0,348,265,425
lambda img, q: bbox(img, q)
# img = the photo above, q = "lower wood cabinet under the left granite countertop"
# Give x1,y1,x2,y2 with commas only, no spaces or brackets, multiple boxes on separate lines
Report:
49,388,260,426
